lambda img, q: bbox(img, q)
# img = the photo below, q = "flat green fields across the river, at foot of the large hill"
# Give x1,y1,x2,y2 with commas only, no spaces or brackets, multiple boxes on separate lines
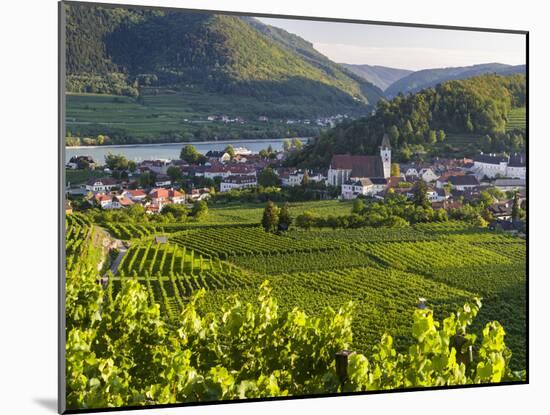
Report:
66,88,317,142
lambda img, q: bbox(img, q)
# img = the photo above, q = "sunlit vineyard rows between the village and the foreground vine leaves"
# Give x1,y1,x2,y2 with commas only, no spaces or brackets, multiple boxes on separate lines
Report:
83,201,526,369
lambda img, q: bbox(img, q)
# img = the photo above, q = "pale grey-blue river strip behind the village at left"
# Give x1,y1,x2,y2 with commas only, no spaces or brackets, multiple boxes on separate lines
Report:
65,138,308,163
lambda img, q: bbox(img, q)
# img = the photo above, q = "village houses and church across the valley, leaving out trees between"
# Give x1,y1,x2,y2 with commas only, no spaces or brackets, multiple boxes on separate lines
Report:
67,135,527,228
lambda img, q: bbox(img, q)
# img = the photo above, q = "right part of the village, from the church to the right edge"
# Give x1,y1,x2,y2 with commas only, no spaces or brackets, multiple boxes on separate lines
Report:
327,135,527,228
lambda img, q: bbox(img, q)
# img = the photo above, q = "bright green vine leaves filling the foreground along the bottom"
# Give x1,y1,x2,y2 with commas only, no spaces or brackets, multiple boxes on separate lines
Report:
66,266,524,409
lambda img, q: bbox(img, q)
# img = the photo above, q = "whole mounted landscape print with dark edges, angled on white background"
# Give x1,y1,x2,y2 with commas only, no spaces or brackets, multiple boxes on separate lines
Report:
59,2,528,413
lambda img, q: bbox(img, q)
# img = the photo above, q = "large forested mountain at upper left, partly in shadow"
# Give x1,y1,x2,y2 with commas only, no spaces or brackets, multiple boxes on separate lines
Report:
66,4,383,115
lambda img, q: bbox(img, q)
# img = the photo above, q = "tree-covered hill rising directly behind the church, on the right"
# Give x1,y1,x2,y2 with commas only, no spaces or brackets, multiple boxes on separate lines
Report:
289,75,526,167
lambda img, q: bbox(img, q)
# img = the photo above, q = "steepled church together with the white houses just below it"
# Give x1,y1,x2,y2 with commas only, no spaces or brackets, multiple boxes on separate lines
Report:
327,134,391,199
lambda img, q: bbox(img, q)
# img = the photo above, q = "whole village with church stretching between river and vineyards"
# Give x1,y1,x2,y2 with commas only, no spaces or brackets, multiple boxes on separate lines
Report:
66,135,526,230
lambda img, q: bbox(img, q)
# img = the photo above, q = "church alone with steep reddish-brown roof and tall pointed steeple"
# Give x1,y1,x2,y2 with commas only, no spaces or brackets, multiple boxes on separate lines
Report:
327,134,391,186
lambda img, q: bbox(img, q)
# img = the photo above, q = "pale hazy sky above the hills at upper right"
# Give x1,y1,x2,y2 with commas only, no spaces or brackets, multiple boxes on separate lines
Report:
259,18,525,70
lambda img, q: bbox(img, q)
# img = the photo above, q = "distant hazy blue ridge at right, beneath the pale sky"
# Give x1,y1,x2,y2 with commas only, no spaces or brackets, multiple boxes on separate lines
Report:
385,63,525,98
